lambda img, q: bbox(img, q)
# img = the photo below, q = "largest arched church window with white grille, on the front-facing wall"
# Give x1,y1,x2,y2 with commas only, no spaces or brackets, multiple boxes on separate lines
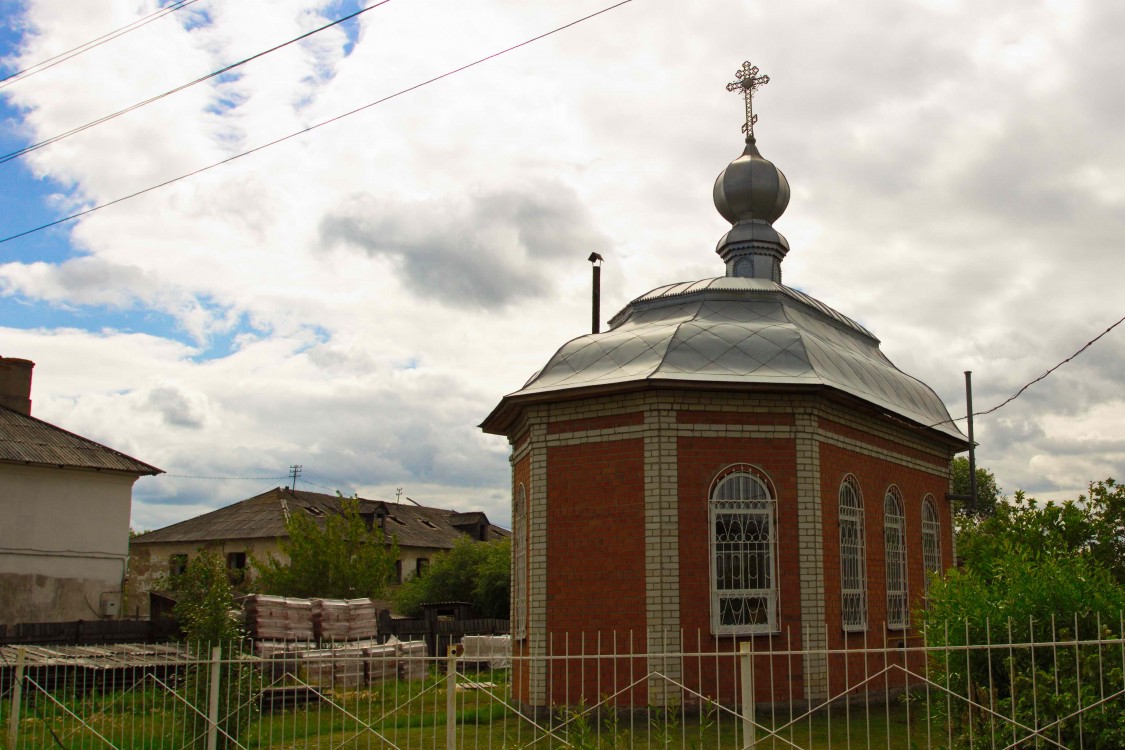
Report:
709,464,777,634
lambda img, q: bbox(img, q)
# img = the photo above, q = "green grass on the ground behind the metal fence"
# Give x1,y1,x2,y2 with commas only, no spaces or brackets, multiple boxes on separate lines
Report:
0,672,945,750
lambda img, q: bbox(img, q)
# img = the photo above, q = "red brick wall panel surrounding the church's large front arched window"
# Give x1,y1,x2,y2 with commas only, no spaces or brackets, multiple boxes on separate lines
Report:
677,437,803,703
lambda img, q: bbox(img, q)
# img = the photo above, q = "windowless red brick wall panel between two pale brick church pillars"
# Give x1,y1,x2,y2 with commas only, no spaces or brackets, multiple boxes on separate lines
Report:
547,439,646,705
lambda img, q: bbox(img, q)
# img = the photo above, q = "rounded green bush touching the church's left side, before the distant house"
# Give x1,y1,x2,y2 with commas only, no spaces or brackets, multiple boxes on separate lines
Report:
395,536,512,620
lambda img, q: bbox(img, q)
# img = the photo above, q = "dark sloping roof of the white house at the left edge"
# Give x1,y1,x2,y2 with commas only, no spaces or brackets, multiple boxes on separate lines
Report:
0,406,164,475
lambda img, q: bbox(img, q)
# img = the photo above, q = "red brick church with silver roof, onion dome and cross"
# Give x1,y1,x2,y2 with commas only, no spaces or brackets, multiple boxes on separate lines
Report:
482,64,968,706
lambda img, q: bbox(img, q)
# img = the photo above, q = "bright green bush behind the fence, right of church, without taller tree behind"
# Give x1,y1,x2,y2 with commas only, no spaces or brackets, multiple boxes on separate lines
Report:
918,539,1125,748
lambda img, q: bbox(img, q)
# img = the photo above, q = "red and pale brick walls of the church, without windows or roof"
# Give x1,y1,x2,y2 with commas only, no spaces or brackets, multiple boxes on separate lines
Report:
501,390,957,706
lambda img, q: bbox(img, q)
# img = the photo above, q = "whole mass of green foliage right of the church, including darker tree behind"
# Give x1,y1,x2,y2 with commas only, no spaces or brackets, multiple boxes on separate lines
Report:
919,480,1125,748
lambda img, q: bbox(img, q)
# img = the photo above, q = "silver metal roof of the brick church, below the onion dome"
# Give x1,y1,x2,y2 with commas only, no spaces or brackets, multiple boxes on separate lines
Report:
486,277,965,442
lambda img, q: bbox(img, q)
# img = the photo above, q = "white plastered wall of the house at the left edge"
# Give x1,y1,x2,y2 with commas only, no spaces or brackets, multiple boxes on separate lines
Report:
0,464,136,625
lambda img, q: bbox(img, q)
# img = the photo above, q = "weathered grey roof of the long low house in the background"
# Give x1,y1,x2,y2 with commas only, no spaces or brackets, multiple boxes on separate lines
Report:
129,487,509,549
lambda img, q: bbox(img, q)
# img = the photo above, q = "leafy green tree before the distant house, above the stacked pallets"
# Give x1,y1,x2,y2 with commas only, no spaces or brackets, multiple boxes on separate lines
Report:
251,498,398,599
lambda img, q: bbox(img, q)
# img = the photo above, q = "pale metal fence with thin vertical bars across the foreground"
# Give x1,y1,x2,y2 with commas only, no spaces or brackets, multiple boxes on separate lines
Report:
0,618,1125,750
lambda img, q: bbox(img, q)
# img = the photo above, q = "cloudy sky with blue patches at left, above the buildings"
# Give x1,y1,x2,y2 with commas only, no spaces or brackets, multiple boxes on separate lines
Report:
0,0,1125,530
